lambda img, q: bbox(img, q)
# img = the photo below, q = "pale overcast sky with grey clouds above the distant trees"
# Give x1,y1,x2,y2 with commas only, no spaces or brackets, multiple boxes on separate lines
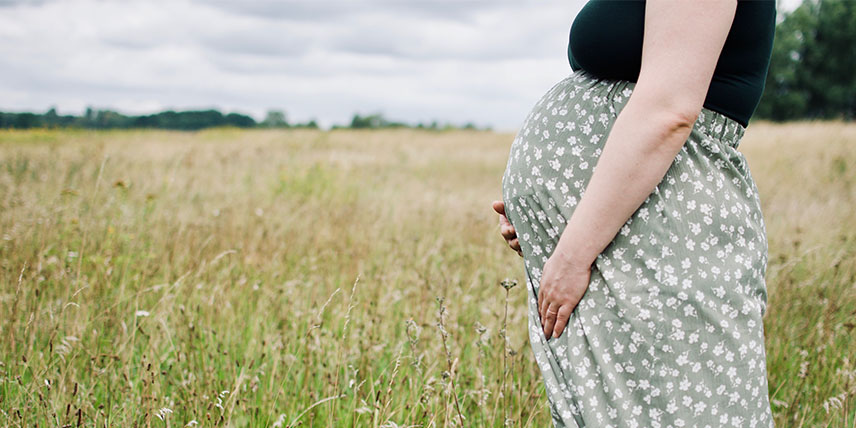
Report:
0,0,799,130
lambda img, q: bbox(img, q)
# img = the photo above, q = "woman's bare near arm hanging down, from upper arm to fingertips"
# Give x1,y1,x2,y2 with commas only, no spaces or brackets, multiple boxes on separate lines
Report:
539,0,737,337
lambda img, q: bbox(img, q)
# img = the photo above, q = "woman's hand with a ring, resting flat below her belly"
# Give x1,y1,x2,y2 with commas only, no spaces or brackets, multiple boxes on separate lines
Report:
538,249,591,339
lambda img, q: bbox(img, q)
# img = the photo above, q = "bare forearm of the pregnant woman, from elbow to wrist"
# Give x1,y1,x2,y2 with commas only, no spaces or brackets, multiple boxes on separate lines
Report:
555,94,692,268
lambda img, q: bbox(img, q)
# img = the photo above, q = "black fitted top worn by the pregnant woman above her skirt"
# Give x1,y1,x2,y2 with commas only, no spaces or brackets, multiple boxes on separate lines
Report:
568,0,776,127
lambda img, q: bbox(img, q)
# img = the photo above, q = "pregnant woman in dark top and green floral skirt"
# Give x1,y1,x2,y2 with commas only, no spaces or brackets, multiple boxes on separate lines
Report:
493,0,776,428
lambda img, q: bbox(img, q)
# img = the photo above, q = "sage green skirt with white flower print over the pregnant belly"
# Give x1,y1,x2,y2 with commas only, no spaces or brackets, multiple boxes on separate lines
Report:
502,70,774,428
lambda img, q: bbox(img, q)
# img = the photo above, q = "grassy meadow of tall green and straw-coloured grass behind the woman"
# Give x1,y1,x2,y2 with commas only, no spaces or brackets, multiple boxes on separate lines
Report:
0,122,856,427
